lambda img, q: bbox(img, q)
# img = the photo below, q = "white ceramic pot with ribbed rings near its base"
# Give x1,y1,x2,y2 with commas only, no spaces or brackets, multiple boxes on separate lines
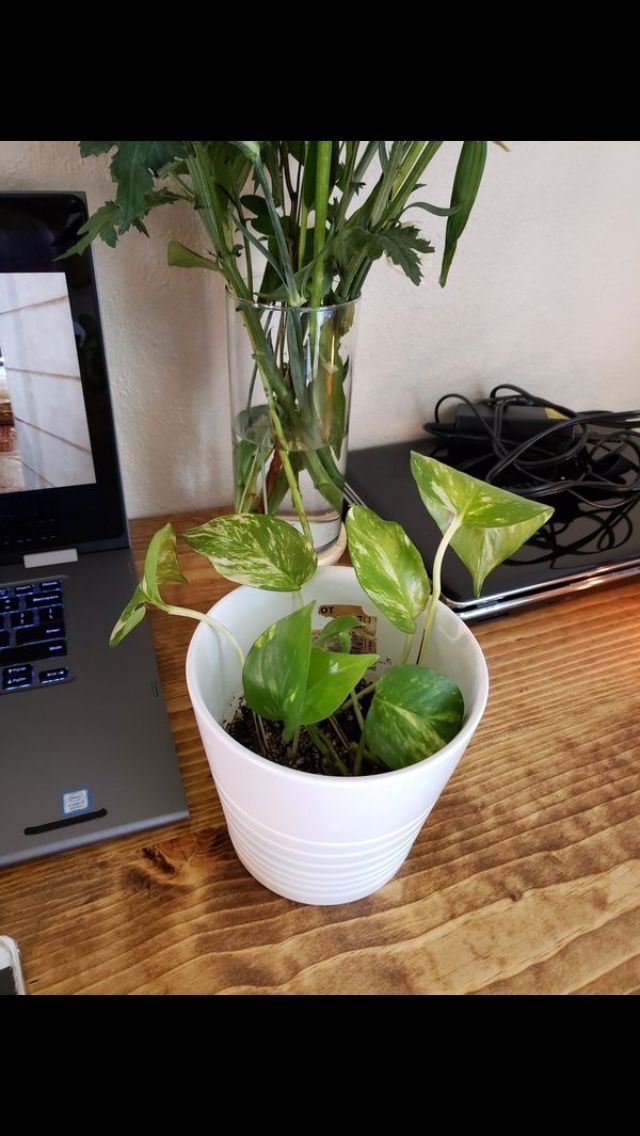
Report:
186,568,489,904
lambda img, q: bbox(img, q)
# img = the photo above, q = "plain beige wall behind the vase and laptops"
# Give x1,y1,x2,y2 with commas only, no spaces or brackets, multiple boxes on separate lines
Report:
0,141,640,516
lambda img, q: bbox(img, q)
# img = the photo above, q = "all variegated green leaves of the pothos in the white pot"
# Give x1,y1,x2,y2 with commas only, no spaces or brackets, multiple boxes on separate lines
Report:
111,443,552,774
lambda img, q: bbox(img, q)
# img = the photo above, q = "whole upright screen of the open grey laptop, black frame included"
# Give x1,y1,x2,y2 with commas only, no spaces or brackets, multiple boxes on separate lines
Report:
0,193,126,562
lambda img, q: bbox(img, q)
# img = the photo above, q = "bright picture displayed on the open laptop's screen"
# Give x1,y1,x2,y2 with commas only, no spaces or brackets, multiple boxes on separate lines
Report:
0,272,95,493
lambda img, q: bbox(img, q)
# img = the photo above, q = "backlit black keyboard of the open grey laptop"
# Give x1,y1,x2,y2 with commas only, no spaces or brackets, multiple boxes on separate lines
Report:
0,579,70,694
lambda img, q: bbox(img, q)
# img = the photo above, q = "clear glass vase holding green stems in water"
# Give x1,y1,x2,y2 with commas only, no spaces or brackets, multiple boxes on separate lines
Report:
226,293,358,558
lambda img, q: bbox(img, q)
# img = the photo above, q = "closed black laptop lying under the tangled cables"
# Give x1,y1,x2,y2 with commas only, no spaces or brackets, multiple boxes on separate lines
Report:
346,435,640,620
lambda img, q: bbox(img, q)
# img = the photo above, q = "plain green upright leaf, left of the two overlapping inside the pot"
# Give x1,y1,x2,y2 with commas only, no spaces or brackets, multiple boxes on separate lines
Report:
242,602,314,742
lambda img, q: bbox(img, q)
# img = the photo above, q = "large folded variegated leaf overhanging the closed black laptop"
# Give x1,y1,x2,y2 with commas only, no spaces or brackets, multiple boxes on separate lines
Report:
412,453,554,595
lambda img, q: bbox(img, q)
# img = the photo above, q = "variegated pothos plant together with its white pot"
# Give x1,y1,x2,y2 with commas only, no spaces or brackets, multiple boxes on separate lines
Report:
111,453,552,903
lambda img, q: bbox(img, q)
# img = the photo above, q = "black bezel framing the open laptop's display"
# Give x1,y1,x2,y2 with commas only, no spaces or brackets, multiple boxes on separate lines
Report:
0,191,128,563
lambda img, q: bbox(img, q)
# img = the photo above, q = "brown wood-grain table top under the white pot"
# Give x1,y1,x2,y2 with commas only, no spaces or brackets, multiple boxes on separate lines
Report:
0,515,640,994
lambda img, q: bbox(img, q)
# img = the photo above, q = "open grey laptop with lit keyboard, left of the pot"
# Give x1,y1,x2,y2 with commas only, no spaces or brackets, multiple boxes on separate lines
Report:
0,193,189,864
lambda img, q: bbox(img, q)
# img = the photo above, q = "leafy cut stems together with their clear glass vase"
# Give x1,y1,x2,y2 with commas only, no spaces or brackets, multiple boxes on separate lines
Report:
70,141,502,550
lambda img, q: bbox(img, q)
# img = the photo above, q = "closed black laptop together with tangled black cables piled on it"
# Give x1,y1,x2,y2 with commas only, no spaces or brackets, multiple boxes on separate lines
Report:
346,392,640,620
